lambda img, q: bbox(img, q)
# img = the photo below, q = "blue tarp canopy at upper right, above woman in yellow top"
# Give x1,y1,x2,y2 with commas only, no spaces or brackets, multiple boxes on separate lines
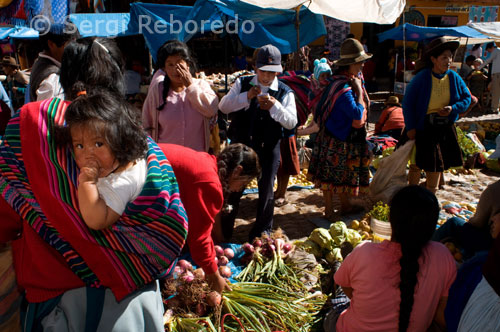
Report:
377,23,488,42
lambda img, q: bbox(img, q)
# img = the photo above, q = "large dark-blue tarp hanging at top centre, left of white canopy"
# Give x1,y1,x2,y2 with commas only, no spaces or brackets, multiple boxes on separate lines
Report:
130,0,326,61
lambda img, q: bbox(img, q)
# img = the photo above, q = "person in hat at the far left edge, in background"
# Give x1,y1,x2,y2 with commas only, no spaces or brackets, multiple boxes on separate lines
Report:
1,55,30,110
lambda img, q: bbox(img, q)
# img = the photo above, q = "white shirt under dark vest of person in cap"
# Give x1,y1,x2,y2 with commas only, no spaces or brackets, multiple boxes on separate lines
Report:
219,75,297,129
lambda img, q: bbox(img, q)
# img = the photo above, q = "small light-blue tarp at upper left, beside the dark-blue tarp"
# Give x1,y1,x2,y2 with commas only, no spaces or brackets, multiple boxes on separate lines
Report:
69,13,137,37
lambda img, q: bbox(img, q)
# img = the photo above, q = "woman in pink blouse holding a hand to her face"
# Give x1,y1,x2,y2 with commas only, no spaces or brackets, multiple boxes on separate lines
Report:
142,40,219,151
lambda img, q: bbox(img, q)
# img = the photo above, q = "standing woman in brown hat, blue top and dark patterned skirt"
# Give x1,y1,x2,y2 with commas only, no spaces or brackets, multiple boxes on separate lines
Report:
309,38,372,219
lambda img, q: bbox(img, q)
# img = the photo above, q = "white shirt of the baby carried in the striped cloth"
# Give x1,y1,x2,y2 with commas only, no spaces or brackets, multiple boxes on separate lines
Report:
97,159,147,215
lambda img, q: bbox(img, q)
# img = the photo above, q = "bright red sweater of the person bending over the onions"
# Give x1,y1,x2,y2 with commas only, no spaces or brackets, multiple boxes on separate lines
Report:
159,144,224,274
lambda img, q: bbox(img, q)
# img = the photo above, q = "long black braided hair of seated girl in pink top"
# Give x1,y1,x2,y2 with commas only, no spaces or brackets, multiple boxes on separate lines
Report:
389,186,439,332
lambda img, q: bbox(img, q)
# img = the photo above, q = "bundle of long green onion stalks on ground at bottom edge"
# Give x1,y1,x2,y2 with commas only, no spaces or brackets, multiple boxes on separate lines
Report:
222,282,326,332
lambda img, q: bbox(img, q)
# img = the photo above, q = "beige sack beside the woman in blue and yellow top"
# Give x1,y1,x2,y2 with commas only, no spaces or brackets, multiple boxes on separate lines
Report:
370,140,415,203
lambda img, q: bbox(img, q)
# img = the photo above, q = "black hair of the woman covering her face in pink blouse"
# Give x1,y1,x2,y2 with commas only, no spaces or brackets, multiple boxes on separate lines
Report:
156,40,196,111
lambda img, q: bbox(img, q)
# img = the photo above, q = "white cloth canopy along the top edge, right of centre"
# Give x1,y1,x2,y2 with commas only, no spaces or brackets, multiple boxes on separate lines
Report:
241,0,406,24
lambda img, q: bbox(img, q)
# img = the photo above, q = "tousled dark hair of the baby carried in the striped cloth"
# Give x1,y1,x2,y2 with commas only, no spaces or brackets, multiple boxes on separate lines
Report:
61,91,148,166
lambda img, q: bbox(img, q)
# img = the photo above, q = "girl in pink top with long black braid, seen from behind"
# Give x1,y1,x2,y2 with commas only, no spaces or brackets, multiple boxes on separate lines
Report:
327,186,456,332
